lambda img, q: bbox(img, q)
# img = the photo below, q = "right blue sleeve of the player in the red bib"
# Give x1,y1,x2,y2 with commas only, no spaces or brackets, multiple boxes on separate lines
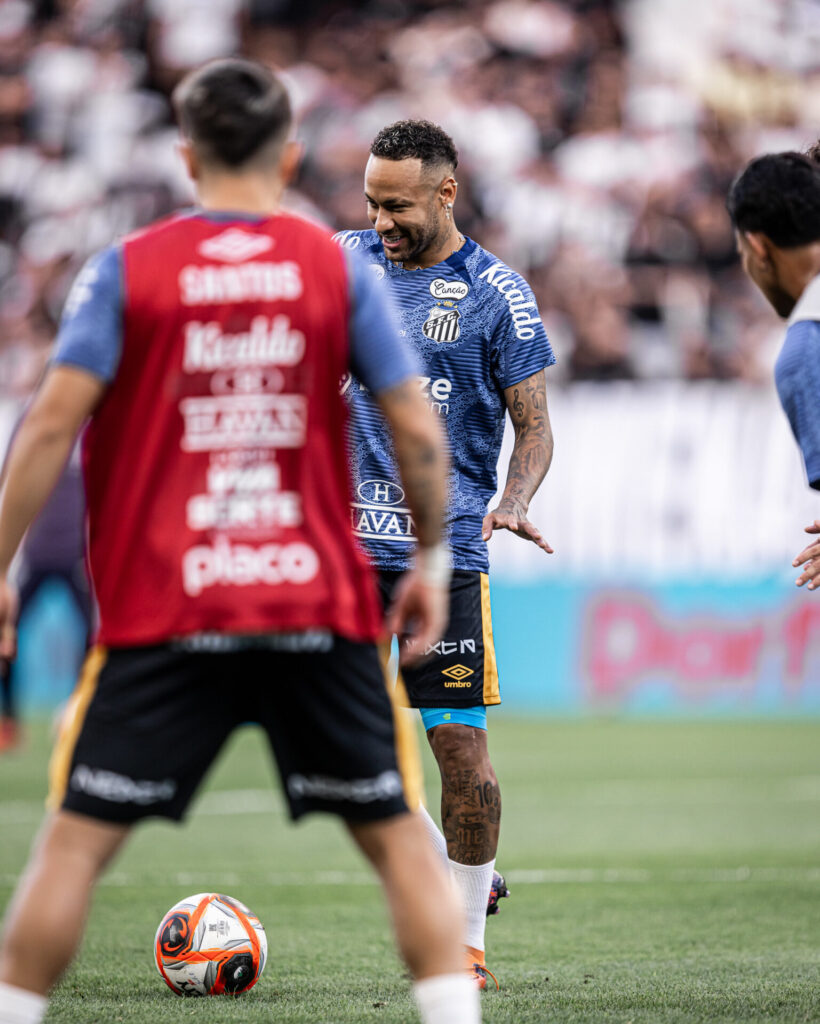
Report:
344,250,422,394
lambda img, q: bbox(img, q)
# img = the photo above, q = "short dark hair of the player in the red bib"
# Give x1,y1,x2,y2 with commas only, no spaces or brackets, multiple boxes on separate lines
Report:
173,58,292,168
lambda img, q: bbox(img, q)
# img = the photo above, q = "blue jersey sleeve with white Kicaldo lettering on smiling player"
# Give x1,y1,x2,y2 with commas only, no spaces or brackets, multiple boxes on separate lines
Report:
491,274,555,388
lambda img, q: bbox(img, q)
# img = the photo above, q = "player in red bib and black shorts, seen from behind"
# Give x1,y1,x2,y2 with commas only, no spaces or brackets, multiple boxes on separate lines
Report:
0,60,479,1024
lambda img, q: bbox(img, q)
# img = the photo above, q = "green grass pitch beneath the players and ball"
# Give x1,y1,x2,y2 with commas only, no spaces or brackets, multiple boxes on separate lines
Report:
0,713,820,1024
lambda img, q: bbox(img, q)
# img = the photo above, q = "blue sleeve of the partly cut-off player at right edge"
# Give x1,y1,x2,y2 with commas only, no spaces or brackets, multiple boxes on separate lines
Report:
775,321,820,490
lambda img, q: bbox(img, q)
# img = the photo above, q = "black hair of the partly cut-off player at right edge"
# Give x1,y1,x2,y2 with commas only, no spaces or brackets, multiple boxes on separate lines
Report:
726,153,820,249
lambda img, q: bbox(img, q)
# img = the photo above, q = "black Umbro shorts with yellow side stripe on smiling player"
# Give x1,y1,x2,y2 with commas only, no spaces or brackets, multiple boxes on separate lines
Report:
379,569,501,708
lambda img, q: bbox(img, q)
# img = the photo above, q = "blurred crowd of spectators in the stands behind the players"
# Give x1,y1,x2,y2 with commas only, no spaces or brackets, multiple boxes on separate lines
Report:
0,0,820,398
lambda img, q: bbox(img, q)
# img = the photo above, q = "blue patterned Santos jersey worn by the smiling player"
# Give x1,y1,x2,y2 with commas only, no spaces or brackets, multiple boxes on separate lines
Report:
336,230,555,572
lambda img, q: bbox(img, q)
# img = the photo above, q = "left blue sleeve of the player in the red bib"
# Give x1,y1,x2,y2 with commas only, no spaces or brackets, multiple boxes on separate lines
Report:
51,246,123,383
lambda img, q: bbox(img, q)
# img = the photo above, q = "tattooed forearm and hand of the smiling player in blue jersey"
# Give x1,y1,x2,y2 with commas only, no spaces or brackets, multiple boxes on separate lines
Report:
482,370,553,554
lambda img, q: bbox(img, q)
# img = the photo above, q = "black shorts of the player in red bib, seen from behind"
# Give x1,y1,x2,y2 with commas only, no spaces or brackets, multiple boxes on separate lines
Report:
49,634,413,822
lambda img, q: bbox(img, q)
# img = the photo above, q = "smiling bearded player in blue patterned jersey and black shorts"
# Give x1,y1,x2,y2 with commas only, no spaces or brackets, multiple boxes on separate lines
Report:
337,121,555,988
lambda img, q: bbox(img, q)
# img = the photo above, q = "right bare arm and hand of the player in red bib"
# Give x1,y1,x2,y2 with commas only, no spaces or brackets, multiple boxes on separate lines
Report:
378,377,449,665
